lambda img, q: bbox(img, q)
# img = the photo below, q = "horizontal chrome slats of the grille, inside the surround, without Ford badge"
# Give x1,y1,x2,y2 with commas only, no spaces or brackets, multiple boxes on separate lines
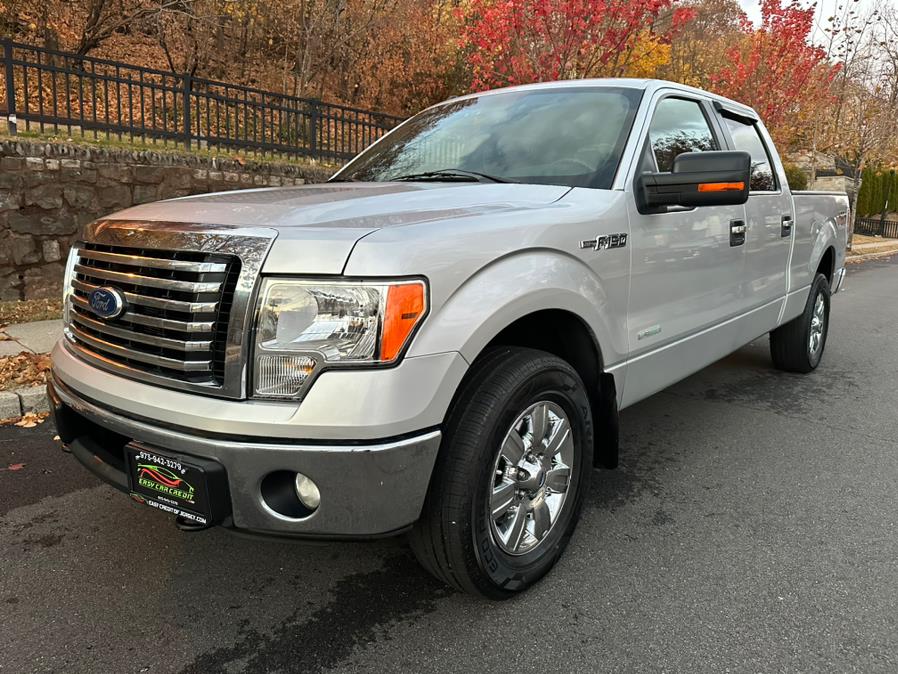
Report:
67,243,241,387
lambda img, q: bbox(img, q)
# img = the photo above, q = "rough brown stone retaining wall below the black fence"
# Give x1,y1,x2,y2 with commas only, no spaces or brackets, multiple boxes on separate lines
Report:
0,140,332,300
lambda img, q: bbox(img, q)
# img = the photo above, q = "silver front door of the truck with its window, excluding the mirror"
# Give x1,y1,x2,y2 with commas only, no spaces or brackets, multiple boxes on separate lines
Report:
623,92,746,405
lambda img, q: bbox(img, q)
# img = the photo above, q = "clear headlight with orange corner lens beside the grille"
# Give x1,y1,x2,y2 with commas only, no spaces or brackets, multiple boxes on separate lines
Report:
254,279,427,398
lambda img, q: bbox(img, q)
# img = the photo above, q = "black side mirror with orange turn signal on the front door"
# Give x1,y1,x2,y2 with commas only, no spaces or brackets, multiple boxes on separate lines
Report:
636,151,751,212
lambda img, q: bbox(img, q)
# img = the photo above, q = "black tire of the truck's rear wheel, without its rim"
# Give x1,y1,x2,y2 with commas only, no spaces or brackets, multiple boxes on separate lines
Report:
770,274,830,374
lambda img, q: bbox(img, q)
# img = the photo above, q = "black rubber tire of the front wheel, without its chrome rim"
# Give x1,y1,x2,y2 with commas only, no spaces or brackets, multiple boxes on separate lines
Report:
410,347,593,599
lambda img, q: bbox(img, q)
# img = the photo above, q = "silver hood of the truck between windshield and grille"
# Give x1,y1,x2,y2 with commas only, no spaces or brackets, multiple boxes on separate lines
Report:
108,183,570,274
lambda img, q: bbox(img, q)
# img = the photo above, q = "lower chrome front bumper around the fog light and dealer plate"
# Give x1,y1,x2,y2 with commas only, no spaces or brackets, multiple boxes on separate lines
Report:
48,377,440,538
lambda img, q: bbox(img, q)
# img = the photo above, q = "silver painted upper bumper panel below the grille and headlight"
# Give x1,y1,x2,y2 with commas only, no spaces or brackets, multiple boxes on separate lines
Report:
51,338,468,444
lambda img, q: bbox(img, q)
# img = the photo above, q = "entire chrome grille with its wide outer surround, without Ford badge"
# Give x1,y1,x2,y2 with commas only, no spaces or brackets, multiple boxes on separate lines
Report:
64,220,277,399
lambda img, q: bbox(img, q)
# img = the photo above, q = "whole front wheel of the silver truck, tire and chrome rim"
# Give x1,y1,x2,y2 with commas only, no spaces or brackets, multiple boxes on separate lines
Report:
411,347,593,599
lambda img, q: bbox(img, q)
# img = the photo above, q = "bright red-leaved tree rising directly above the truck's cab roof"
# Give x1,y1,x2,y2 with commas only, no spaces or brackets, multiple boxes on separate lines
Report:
461,0,689,89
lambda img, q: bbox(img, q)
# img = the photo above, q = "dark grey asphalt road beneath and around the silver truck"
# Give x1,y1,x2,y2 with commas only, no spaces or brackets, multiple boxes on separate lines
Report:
0,257,898,672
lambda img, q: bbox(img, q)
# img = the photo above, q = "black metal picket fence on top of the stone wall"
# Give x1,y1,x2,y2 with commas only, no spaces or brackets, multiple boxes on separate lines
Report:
0,40,402,162
